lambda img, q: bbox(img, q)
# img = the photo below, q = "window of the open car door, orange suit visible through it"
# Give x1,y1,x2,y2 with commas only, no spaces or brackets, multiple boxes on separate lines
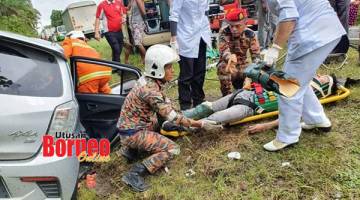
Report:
75,61,138,96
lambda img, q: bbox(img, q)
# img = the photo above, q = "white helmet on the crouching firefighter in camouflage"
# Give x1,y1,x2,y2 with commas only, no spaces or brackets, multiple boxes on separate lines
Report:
144,44,180,79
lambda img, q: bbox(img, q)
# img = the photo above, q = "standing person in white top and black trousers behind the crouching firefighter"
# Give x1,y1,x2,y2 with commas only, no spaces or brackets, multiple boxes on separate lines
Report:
169,0,211,110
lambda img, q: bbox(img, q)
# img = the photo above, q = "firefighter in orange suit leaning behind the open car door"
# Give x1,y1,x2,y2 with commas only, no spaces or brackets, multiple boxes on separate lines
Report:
62,31,111,94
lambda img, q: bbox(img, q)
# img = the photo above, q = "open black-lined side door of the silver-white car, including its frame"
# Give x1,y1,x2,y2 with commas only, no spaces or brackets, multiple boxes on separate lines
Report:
70,57,141,146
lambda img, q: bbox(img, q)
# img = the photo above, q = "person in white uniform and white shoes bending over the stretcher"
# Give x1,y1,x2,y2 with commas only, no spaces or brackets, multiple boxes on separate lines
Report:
264,0,346,151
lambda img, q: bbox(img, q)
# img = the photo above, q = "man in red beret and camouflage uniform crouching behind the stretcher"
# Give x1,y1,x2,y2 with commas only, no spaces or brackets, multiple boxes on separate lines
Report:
217,8,260,96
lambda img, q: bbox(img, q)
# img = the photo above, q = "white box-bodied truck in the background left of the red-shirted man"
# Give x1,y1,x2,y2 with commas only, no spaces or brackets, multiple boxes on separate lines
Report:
61,1,96,38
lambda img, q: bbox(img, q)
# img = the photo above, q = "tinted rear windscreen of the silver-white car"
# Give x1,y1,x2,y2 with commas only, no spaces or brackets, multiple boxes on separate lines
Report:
0,42,63,97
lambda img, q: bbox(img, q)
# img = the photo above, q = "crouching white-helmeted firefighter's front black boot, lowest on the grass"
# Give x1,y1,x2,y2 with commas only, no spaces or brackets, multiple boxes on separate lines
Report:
121,163,150,192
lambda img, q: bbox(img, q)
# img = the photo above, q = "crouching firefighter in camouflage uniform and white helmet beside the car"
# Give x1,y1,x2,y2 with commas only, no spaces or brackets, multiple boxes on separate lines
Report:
117,44,221,192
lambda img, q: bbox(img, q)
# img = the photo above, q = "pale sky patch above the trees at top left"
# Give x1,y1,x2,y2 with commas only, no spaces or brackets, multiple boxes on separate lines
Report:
31,0,100,30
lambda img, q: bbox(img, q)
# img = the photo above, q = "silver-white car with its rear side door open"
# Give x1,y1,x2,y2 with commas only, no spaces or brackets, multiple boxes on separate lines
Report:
0,31,141,200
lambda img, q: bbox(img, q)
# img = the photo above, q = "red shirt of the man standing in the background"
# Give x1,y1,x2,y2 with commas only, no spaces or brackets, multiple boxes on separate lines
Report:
96,0,126,32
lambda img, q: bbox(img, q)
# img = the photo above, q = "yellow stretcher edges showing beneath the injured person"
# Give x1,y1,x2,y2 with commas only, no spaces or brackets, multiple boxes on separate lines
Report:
229,85,350,126
